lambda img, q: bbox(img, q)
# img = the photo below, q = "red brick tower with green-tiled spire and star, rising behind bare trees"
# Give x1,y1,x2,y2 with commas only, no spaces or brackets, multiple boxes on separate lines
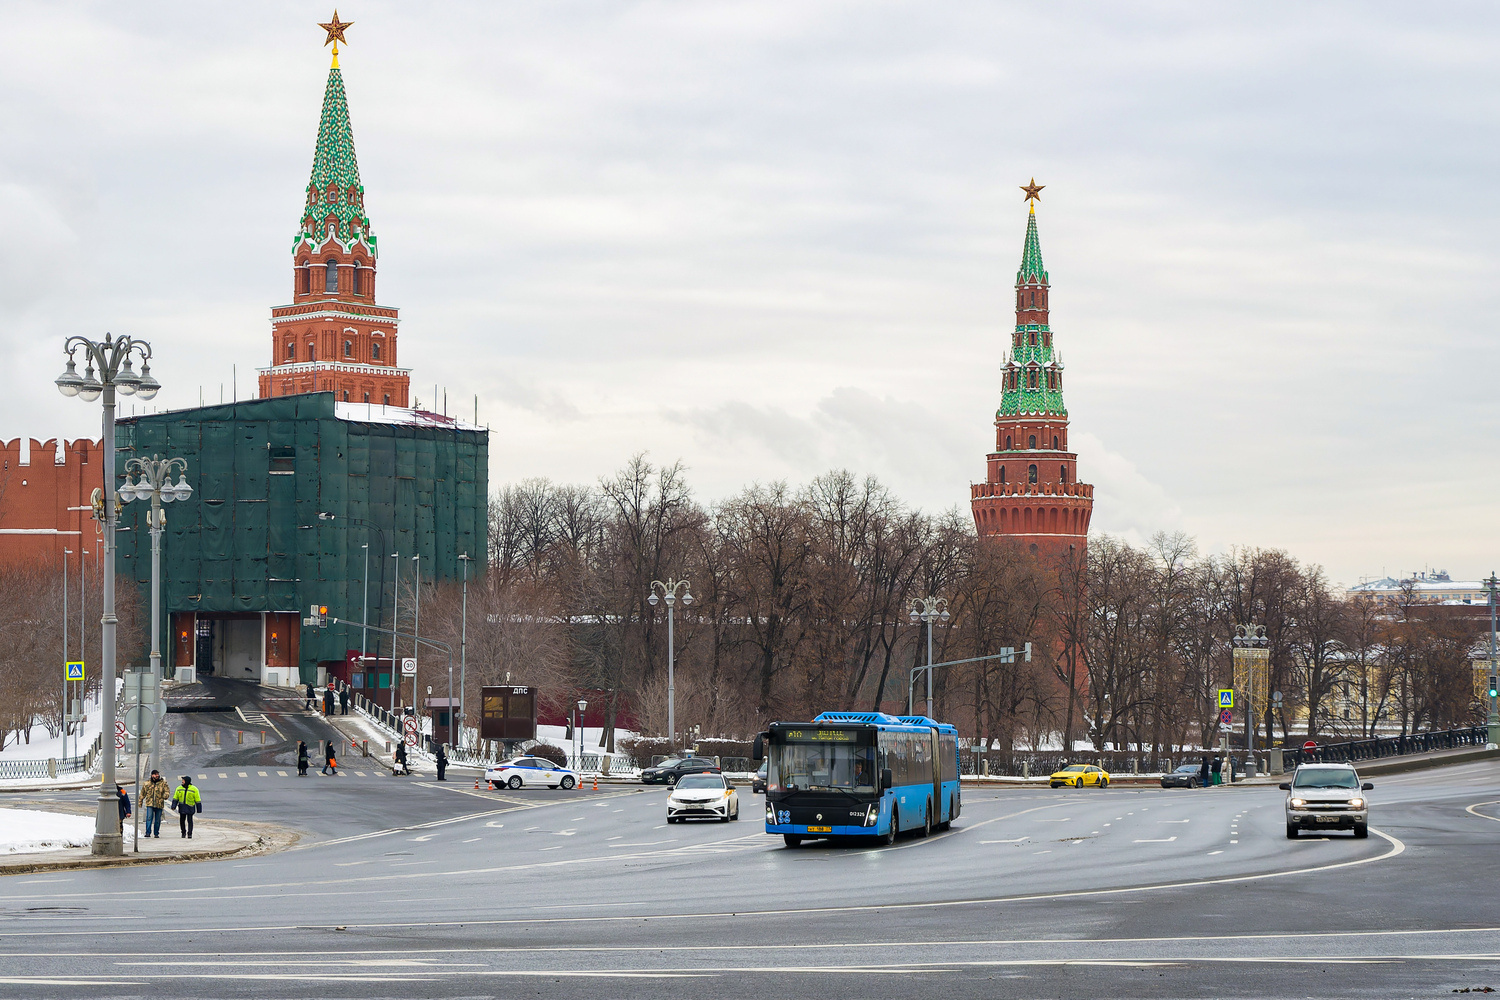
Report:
969,180,1094,556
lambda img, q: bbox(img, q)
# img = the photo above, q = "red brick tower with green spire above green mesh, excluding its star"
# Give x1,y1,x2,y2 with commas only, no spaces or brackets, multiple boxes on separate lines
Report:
260,45,411,406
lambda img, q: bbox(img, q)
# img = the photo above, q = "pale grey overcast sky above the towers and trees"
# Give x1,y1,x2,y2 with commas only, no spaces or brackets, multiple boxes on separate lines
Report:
0,0,1500,583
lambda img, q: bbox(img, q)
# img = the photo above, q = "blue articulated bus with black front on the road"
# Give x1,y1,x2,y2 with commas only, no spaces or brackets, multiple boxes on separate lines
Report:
753,712,963,847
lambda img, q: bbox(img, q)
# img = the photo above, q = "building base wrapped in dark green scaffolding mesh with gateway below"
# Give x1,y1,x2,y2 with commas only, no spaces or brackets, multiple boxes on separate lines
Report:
116,393,489,690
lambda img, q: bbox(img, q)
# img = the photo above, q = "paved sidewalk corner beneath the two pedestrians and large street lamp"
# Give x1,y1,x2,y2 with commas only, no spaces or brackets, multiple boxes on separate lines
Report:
0,807,299,876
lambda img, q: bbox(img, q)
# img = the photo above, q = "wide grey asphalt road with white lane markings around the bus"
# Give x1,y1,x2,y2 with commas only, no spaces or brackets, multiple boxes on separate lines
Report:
0,689,1500,999
